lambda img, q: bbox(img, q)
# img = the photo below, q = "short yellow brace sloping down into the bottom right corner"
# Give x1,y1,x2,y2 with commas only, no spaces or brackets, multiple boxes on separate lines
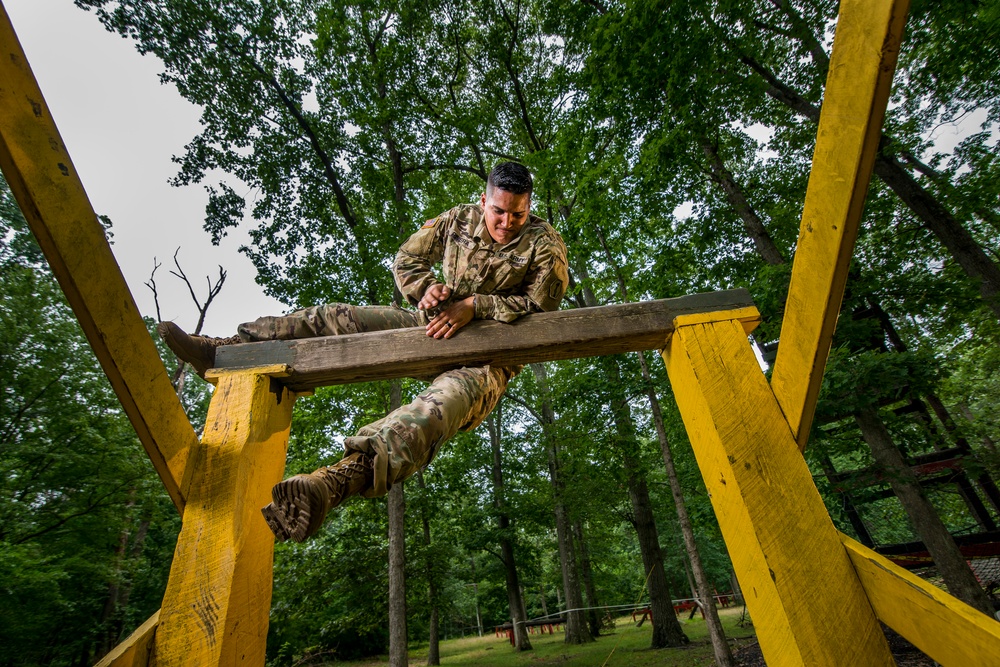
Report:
840,535,1000,667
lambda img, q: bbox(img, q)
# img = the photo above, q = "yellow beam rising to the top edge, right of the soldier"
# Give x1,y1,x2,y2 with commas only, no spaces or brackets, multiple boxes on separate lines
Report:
771,0,909,449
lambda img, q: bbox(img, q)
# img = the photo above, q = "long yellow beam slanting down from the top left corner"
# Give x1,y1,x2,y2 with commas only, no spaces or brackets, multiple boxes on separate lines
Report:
0,4,197,511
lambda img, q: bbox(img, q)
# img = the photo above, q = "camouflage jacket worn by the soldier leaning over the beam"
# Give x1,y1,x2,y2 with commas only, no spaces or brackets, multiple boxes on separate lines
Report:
392,204,569,322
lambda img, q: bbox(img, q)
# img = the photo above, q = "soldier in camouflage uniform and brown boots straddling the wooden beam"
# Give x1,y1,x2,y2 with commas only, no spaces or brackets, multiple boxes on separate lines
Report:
159,162,568,542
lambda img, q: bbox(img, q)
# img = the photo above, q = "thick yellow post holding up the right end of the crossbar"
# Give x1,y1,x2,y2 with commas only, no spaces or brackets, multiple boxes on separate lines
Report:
663,320,894,667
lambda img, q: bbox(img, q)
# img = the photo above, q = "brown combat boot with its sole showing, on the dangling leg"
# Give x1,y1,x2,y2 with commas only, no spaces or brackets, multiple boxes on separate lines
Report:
261,452,375,542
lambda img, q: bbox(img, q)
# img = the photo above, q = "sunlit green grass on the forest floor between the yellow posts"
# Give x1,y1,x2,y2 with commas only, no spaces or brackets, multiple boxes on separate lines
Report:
326,607,754,667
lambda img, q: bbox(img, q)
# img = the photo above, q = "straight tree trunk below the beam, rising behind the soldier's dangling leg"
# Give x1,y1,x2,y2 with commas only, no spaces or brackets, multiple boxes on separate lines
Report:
388,380,409,667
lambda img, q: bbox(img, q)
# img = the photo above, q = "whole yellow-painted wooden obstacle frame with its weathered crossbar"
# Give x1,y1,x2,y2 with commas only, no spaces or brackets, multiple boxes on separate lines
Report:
0,0,1000,667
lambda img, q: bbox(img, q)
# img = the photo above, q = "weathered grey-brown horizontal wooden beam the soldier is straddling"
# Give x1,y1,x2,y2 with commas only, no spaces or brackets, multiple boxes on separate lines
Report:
216,289,759,391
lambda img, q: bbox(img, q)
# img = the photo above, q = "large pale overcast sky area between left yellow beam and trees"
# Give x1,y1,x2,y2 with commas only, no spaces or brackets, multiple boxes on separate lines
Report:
3,0,286,336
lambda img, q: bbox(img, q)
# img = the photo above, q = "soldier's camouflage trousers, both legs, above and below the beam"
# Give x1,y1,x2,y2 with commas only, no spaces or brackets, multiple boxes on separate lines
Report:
239,303,521,498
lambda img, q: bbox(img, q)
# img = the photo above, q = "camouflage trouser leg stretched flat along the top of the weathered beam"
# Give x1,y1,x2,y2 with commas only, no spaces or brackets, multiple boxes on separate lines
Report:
238,303,427,343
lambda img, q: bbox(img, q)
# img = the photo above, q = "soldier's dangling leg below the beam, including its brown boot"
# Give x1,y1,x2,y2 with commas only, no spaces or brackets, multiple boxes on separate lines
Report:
263,366,520,542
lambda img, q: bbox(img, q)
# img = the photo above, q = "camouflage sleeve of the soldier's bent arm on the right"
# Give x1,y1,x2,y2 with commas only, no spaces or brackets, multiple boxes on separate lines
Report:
475,231,569,322
